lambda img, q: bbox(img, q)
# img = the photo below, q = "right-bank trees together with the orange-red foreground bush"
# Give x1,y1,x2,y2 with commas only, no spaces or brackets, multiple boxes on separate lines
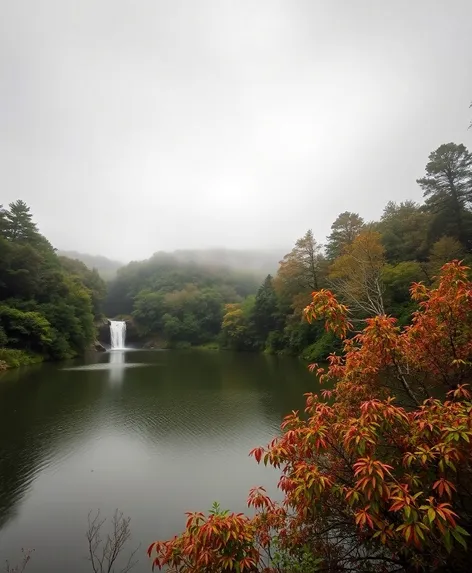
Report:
148,144,472,573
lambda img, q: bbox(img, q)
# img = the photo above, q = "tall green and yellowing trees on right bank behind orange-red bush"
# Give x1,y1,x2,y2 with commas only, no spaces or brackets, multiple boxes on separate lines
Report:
220,143,472,360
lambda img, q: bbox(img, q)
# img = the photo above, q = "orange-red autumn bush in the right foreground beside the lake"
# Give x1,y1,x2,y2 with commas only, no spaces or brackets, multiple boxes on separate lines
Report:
149,261,472,573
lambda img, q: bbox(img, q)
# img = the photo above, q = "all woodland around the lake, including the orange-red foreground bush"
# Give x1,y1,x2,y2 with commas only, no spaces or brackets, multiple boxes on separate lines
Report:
0,143,472,573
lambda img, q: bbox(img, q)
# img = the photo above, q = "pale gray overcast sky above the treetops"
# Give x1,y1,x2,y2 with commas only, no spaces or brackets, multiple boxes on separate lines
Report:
0,0,472,260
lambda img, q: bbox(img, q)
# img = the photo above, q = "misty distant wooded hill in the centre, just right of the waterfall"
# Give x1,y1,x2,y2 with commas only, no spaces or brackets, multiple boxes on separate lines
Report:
105,253,257,348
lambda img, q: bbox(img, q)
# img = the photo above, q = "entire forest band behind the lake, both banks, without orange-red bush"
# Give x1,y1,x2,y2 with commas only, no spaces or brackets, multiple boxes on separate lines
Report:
0,143,472,366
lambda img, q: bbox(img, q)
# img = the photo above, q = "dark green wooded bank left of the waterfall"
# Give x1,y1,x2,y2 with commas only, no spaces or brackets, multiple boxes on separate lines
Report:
0,201,106,368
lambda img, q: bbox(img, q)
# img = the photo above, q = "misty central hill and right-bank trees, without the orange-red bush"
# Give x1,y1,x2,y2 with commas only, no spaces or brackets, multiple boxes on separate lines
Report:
105,143,472,359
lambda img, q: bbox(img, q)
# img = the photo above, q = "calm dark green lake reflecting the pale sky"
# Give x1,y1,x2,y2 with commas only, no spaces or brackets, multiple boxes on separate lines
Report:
0,350,316,573
